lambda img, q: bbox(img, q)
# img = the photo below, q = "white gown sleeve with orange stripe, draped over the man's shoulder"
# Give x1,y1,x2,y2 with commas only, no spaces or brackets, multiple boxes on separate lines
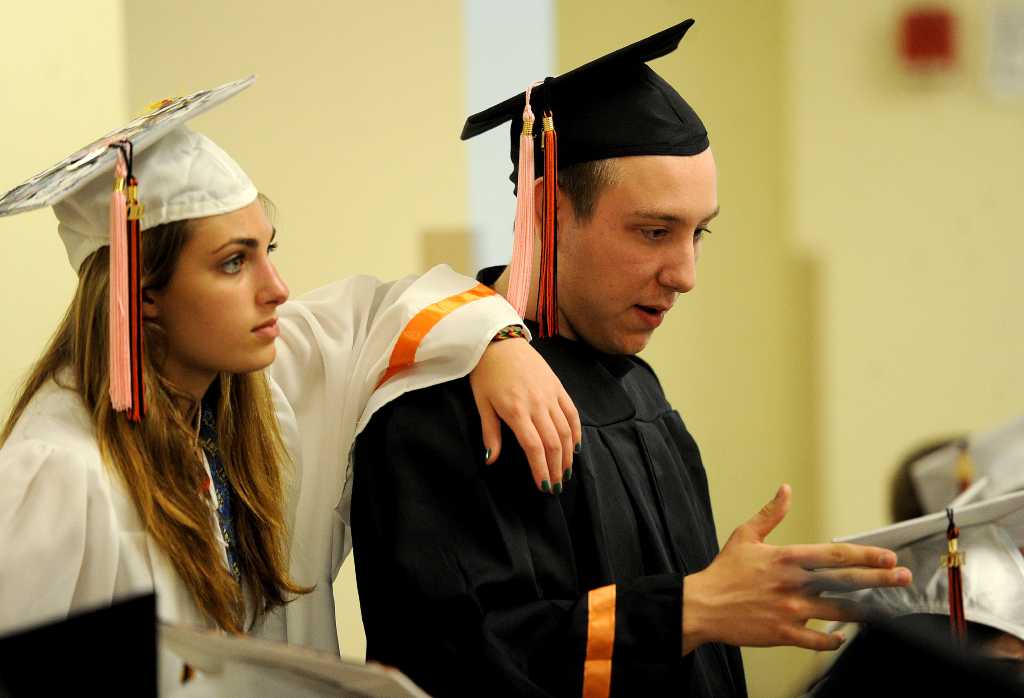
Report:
268,265,521,651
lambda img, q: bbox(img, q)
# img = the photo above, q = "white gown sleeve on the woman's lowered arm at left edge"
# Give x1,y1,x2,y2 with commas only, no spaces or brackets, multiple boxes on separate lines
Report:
0,439,118,634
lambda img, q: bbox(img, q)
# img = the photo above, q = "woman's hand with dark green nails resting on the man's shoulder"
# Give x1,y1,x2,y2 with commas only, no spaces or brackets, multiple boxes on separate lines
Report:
469,339,583,494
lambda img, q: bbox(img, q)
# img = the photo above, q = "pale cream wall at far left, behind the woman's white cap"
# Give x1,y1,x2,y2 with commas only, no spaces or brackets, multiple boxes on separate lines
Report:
0,0,127,407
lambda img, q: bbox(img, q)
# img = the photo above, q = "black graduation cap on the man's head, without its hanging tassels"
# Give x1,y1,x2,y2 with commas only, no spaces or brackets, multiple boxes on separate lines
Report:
462,19,709,182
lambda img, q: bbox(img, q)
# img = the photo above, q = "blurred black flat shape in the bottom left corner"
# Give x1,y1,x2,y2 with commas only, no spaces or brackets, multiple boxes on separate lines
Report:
0,594,157,698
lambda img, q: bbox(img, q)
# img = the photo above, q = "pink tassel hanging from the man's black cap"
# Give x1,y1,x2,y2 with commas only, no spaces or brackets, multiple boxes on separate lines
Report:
508,83,541,317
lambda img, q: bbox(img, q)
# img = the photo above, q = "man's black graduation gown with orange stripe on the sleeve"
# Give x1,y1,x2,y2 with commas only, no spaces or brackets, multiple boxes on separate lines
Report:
352,329,746,698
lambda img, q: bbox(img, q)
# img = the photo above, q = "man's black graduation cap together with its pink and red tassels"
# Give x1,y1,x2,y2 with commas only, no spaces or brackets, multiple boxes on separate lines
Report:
462,19,708,337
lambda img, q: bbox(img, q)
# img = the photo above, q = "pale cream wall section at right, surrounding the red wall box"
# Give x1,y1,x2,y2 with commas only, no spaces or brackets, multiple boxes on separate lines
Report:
787,0,1024,536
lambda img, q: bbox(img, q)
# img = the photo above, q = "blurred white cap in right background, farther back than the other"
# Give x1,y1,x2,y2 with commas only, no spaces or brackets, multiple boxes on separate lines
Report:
910,417,1024,512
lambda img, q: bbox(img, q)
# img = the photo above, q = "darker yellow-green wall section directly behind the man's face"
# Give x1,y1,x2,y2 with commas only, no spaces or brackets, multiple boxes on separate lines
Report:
557,0,818,696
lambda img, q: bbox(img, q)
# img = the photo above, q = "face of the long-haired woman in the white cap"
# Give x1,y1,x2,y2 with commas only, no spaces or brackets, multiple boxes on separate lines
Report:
143,200,288,398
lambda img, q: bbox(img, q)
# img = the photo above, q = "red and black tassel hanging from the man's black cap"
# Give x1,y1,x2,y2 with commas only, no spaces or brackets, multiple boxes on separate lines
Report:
537,112,558,338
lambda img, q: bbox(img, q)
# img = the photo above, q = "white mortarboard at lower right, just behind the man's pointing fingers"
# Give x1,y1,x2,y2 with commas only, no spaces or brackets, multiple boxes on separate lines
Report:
836,492,1024,640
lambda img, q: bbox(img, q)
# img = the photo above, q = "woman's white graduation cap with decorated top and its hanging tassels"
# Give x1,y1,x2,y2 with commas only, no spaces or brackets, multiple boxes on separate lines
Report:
0,76,257,422
